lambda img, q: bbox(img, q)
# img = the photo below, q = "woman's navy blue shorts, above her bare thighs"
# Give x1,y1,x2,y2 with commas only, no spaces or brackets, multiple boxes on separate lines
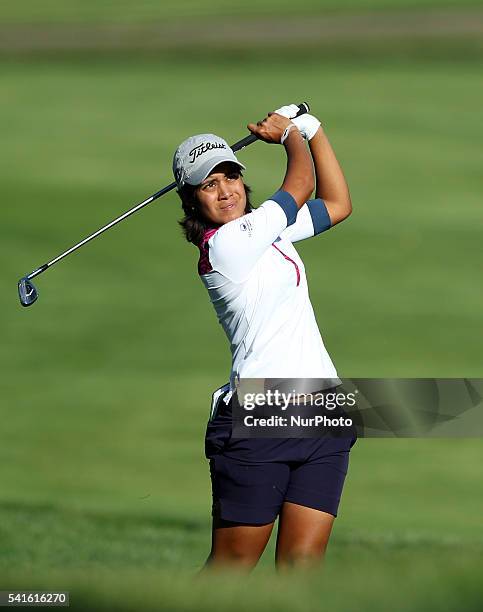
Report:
205,394,355,525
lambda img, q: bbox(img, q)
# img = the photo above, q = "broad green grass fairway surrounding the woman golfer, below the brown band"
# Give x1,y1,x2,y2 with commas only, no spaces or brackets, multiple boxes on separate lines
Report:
0,1,483,610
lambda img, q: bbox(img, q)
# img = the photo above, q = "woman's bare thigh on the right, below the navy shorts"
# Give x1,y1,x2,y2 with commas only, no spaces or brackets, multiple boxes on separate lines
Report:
276,502,335,568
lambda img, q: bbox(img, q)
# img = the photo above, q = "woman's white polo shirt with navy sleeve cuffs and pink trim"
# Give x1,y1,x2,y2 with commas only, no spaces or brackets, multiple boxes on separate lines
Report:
198,191,337,389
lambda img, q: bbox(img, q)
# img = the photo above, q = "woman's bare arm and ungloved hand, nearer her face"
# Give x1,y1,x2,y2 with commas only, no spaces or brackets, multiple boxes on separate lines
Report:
248,113,315,208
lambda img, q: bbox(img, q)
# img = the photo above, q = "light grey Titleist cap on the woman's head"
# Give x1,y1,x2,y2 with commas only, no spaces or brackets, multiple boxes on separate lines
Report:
173,134,245,187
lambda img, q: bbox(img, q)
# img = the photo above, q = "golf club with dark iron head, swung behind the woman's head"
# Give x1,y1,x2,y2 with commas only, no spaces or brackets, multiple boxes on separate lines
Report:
18,102,310,306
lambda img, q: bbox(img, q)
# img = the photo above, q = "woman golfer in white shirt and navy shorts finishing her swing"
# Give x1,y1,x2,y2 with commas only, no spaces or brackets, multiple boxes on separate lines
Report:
173,105,354,568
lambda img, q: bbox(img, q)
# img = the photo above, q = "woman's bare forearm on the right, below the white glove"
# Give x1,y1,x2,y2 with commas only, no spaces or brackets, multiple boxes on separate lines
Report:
309,127,352,225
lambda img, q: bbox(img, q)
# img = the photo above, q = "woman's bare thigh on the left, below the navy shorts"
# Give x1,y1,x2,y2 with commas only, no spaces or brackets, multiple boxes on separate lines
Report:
205,518,274,570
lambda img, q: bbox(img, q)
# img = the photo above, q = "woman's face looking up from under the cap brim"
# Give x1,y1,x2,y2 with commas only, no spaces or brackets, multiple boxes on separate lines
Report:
196,162,247,225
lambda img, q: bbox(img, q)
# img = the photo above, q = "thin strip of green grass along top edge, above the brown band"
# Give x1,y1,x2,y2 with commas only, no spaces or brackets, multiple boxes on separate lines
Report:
0,0,482,24
